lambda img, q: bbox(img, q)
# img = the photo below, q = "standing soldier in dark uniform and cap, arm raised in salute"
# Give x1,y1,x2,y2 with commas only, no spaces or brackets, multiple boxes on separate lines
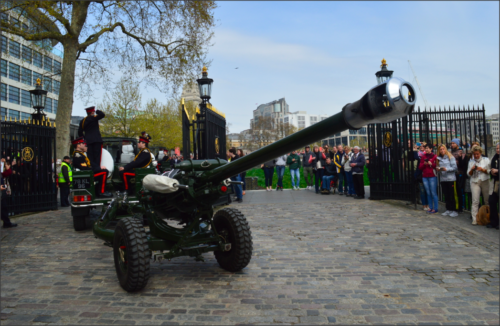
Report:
78,106,105,173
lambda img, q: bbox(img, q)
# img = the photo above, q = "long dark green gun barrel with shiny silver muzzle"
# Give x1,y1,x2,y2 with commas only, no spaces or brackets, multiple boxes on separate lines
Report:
202,77,416,182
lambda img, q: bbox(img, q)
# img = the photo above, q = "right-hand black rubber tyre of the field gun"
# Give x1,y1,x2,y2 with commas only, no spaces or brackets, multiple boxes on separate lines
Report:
213,208,253,272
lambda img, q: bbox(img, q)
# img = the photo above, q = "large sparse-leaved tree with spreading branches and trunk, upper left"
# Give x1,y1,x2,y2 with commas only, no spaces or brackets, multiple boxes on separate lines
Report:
0,0,216,157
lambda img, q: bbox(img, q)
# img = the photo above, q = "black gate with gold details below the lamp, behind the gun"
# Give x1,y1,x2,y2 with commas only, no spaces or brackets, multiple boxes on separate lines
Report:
182,100,226,160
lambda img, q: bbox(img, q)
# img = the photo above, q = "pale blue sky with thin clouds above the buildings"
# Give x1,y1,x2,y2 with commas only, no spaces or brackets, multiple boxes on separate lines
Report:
73,1,500,133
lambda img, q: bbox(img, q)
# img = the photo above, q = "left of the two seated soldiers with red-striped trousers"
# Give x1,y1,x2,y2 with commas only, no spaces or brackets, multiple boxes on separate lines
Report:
72,137,113,197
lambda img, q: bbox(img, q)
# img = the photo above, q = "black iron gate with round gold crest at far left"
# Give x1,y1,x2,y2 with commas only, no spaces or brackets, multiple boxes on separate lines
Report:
0,121,57,215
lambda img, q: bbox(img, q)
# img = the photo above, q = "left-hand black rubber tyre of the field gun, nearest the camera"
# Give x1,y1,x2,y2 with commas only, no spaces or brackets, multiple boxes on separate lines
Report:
113,217,151,292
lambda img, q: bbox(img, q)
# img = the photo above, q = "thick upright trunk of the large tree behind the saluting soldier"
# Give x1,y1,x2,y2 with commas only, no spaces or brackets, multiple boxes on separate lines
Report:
56,42,78,159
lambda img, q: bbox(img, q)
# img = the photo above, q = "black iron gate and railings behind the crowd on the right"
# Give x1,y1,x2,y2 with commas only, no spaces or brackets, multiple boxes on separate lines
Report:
368,106,486,204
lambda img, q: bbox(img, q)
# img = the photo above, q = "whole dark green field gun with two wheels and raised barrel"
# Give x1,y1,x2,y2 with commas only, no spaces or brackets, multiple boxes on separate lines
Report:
93,78,416,292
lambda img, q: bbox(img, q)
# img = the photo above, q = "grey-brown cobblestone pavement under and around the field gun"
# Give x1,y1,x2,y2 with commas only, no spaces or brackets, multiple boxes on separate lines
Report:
1,195,499,325
